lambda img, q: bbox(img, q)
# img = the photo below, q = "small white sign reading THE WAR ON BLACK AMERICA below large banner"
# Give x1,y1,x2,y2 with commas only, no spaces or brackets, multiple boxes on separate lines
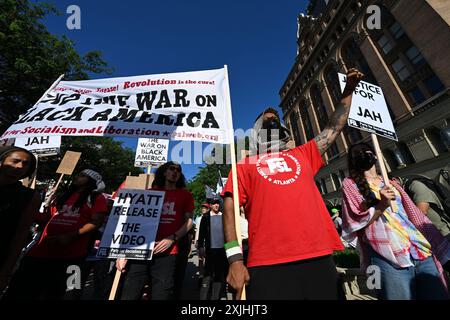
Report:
134,138,169,167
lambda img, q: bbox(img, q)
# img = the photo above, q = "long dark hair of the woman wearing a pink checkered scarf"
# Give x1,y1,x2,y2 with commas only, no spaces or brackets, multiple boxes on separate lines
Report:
347,142,380,208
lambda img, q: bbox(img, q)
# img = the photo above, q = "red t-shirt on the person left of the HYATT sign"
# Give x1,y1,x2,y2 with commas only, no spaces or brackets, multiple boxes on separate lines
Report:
28,193,107,259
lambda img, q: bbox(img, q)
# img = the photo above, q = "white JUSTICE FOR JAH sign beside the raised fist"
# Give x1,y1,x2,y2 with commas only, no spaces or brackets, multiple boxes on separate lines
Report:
338,73,397,141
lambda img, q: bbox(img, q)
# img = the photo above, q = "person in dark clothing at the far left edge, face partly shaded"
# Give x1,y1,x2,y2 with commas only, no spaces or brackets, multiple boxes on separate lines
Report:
0,146,41,293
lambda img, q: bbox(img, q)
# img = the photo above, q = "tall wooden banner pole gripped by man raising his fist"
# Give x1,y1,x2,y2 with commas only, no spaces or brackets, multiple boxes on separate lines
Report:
224,65,246,300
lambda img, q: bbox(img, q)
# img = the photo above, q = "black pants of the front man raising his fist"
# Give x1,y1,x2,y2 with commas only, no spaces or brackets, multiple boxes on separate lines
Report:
247,256,345,300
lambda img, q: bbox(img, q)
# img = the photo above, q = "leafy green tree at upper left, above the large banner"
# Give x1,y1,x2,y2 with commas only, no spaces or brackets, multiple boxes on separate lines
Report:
0,0,112,132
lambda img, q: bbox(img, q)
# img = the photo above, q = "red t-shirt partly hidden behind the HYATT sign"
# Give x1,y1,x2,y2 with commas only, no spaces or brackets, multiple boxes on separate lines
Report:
153,188,194,254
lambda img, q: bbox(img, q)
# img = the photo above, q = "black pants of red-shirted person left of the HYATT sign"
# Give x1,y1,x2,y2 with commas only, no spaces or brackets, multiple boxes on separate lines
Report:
4,257,84,300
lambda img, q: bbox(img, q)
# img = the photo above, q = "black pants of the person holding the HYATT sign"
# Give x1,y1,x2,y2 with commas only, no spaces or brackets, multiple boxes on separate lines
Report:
121,254,176,300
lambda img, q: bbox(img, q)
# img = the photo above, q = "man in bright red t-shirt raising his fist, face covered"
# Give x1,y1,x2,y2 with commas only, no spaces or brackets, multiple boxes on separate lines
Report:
223,69,362,299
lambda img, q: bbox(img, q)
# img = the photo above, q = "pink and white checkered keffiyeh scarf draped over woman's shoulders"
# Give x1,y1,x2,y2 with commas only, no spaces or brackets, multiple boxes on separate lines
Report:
342,178,450,287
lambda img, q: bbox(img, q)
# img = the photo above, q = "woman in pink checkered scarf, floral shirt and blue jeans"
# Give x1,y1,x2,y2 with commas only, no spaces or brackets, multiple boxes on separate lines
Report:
343,143,450,300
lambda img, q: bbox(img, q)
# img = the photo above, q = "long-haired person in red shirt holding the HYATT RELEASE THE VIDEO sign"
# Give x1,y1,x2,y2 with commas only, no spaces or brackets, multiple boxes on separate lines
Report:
116,161,194,300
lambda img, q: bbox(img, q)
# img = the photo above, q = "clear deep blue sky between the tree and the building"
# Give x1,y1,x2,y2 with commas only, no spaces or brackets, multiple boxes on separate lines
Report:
44,0,308,179
